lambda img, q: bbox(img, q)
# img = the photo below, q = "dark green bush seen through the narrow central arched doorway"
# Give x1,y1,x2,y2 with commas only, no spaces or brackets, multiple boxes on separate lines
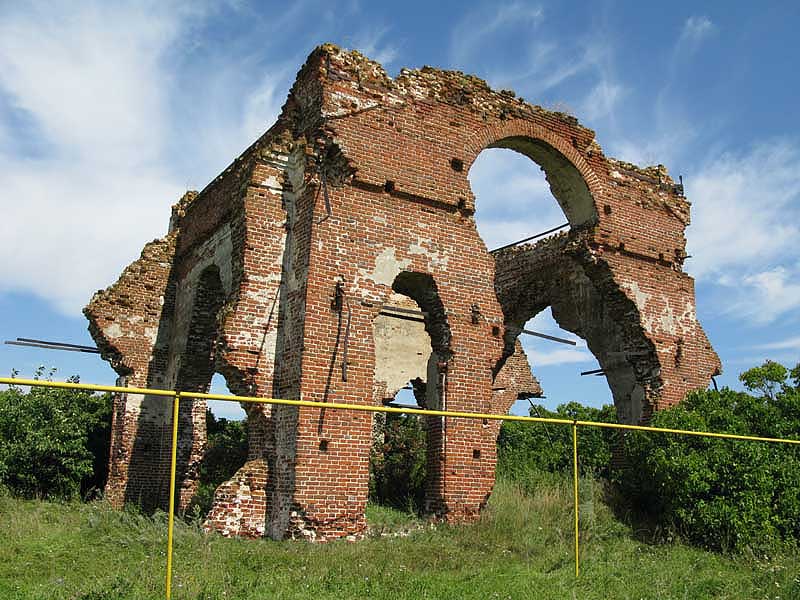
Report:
370,413,426,512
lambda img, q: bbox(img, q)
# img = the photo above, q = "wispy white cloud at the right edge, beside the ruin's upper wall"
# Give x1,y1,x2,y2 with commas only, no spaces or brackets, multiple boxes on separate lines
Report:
687,139,800,325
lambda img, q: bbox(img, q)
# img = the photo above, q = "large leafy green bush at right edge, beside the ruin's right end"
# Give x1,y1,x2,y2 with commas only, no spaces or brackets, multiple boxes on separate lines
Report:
619,361,800,551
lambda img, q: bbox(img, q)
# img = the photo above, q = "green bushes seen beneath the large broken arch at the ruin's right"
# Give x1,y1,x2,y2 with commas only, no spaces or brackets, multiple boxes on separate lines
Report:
497,402,618,485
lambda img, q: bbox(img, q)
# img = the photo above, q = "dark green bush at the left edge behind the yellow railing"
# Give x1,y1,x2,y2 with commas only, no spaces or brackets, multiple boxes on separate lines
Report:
0,370,111,499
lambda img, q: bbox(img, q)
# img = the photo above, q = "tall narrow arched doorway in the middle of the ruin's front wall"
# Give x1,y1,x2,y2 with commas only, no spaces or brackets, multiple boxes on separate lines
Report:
370,271,451,513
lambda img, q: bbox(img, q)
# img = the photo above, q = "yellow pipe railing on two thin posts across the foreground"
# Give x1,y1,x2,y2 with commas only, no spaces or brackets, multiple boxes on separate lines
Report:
0,377,800,600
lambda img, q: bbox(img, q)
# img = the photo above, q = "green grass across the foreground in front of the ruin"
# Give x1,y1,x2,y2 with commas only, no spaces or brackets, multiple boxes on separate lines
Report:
0,478,800,600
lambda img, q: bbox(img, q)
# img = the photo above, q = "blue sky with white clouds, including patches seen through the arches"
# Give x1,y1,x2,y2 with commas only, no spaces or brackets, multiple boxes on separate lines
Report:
0,0,800,414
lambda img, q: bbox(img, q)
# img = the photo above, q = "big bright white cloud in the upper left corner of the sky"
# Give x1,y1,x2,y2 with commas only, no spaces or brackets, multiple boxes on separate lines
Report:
0,5,197,315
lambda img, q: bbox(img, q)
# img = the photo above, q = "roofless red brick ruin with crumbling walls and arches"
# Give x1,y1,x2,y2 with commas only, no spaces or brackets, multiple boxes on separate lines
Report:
85,45,720,541
